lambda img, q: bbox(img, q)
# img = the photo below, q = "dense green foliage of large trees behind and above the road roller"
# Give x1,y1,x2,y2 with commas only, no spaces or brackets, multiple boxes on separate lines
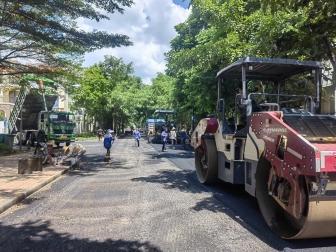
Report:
166,0,336,121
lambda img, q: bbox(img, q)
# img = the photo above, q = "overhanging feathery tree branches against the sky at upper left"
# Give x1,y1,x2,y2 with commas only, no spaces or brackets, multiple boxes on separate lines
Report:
0,0,132,75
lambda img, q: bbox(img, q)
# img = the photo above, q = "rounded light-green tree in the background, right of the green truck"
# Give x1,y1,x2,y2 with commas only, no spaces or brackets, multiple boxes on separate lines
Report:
74,56,148,130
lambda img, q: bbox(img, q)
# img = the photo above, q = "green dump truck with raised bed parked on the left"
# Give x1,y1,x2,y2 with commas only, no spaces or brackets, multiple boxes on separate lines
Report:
8,84,76,145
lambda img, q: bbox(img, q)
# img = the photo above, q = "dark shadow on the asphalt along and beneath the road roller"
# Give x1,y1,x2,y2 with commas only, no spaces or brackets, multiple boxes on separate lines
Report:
132,159,336,250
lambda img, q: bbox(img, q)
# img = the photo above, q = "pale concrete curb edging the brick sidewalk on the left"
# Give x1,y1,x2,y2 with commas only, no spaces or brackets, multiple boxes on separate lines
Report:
0,167,70,214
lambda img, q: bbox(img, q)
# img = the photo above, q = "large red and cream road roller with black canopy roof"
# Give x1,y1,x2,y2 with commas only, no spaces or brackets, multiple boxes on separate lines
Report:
191,57,336,239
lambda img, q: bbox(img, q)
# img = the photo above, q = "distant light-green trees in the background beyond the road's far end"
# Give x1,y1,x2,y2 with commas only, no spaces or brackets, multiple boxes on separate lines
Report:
74,56,174,129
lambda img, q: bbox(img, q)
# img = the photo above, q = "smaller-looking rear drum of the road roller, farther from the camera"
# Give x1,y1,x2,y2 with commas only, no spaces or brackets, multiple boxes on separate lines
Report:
195,138,218,184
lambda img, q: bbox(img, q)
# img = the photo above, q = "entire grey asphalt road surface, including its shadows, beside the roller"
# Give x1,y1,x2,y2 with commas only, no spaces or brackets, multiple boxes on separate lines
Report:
0,139,336,251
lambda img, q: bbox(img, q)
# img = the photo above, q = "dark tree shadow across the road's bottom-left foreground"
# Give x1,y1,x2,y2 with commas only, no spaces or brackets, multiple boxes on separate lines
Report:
0,221,161,252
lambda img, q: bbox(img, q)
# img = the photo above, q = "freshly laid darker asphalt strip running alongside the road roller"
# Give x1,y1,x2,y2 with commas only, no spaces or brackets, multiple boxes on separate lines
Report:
152,144,336,251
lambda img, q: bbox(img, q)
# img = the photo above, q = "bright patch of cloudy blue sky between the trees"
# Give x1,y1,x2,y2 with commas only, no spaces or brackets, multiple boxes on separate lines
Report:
78,0,190,84
